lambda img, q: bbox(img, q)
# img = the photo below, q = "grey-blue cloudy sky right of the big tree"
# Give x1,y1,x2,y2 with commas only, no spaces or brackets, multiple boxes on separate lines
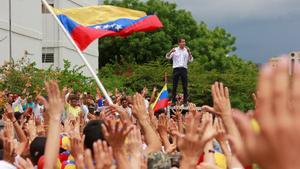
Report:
99,0,300,63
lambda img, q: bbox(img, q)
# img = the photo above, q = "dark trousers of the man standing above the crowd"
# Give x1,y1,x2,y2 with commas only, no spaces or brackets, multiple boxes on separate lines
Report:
172,67,188,103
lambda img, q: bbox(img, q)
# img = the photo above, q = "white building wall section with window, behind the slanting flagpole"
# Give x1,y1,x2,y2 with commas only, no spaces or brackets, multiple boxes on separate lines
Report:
43,0,98,75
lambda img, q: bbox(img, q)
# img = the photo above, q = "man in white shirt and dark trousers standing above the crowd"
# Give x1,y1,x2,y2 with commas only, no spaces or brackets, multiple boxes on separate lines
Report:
166,38,193,104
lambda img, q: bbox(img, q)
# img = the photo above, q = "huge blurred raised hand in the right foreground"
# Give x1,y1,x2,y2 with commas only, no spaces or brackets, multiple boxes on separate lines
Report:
236,57,300,169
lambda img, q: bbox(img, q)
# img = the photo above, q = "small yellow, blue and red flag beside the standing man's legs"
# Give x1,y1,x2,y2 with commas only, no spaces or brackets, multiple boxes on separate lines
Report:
152,84,169,112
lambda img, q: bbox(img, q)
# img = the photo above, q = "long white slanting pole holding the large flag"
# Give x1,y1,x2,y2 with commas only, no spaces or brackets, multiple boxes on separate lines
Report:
42,0,113,104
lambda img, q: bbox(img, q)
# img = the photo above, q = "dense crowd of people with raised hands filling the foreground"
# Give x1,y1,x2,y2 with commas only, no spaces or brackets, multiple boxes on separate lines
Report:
0,57,300,169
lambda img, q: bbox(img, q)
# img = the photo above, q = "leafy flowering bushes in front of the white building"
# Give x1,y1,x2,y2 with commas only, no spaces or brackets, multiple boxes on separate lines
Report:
0,58,96,97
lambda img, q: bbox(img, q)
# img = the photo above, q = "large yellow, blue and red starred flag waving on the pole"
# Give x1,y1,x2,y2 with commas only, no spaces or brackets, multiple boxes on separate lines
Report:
54,5,163,50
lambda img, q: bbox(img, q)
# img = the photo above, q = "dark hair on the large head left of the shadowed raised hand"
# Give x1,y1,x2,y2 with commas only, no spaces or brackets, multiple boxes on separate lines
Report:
83,120,104,152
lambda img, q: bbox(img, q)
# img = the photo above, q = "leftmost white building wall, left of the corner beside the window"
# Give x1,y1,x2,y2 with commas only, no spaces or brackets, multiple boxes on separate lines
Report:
0,0,42,65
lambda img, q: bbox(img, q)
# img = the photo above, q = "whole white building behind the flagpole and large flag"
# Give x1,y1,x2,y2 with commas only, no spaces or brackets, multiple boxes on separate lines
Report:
0,0,98,75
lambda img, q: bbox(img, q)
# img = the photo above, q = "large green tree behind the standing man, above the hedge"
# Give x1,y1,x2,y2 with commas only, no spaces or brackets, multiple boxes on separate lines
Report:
99,0,236,69
